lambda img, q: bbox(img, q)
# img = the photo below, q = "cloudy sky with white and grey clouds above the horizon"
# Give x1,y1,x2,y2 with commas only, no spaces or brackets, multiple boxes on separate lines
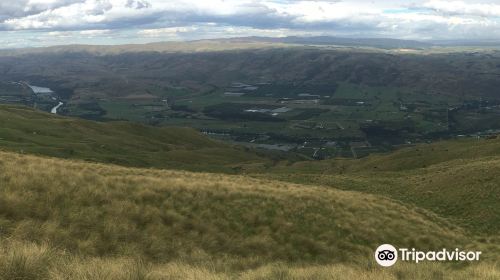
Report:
0,0,500,48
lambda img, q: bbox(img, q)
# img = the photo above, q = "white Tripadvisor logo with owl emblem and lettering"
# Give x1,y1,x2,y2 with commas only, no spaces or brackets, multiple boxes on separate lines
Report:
375,244,482,267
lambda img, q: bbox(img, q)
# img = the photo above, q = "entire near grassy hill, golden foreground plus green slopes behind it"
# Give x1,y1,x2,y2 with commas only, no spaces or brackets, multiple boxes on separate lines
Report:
0,106,500,280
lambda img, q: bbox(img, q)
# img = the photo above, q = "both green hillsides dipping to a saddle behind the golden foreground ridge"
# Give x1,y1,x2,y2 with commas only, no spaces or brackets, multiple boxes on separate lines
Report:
0,106,500,234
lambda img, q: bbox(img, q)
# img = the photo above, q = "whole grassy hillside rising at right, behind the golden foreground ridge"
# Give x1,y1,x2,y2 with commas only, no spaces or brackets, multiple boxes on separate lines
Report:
257,139,500,235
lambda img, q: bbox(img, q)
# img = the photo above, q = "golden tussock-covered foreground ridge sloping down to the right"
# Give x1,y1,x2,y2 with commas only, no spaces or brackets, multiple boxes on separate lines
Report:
0,152,498,279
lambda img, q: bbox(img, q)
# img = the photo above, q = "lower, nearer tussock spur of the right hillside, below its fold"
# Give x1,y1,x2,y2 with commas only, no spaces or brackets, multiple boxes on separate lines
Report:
260,154,500,236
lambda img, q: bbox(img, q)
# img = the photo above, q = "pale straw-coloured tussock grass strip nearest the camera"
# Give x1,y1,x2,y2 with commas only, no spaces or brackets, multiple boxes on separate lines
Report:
0,240,500,280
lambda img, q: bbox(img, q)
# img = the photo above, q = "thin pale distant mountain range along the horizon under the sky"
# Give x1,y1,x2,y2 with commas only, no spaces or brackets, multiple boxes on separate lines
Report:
0,36,500,55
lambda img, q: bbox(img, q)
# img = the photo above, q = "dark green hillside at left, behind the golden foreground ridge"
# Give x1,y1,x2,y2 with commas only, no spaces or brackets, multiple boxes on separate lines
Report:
0,105,276,172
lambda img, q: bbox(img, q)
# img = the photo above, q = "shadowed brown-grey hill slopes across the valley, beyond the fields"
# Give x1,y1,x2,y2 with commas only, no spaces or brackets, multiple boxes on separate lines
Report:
0,44,500,102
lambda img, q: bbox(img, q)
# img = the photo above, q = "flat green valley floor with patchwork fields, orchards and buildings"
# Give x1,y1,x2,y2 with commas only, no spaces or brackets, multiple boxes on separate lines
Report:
0,70,500,162
